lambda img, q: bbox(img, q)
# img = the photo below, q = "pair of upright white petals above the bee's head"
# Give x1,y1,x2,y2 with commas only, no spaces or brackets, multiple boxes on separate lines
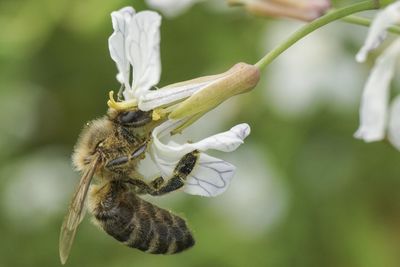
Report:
108,7,161,100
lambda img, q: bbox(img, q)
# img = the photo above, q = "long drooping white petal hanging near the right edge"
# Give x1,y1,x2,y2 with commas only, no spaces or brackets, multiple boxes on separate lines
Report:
354,39,400,142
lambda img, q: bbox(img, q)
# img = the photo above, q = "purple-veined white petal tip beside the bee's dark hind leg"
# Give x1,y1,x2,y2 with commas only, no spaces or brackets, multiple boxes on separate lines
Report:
183,153,236,197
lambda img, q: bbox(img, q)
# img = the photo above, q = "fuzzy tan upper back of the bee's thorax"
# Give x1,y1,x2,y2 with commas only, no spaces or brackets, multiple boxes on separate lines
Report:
72,118,114,171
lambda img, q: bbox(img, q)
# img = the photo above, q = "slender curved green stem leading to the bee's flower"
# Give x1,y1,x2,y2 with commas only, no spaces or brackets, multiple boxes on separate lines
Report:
255,0,386,69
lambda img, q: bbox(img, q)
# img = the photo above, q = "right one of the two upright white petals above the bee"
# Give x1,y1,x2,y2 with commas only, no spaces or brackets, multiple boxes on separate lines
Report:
124,11,161,99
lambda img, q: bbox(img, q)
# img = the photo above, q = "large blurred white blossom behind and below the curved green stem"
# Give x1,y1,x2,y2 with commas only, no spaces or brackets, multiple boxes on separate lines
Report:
261,21,363,117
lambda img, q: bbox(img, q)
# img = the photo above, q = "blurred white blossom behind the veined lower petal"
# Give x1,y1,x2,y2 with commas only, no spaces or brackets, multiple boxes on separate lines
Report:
212,146,289,238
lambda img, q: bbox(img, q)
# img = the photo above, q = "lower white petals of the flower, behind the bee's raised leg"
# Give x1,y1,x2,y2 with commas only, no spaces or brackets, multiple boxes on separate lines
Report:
151,121,250,196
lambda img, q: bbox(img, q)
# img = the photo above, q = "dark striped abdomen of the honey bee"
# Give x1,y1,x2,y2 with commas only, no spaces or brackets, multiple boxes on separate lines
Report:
92,181,195,254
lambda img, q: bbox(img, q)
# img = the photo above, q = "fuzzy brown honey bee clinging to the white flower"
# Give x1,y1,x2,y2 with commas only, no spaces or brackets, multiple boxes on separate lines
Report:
59,108,199,264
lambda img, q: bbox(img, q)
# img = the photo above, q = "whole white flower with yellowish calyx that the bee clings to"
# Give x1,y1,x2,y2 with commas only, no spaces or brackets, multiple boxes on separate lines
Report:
109,7,253,196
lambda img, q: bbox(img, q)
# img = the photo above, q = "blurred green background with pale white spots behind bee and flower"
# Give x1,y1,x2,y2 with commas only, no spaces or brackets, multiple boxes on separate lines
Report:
0,0,400,267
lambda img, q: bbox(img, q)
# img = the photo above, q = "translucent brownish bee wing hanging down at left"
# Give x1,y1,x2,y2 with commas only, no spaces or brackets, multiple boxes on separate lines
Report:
59,158,98,264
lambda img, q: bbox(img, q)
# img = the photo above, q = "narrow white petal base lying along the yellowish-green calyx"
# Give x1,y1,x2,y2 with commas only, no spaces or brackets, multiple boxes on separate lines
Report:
139,81,212,111
